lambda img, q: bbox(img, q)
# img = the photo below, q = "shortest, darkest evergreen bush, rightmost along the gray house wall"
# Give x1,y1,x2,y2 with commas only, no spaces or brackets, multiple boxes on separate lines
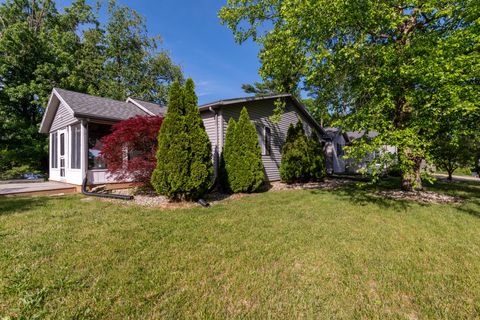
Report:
280,121,325,183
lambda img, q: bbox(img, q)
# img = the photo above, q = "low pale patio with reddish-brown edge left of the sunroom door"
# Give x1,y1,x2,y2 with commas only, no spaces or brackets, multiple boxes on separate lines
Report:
0,181,76,196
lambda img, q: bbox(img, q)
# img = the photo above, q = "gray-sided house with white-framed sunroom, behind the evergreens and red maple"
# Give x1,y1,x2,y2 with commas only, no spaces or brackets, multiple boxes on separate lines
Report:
40,88,325,185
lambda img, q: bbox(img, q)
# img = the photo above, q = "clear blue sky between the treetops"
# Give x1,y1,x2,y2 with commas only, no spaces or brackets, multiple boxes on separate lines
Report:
57,0,261,104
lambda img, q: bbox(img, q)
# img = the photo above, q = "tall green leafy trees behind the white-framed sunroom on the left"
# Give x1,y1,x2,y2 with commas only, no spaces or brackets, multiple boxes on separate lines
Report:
0,0,182,175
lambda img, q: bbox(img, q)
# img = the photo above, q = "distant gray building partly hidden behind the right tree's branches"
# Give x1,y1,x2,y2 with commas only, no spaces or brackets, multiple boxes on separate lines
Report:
323,128,397,174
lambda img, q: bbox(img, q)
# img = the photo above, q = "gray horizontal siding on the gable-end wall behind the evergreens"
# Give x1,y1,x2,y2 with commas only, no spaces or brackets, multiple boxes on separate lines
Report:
222,100,314,181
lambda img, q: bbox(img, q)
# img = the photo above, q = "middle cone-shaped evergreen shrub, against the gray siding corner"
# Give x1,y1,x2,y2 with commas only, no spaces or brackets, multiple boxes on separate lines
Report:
220,108,265,192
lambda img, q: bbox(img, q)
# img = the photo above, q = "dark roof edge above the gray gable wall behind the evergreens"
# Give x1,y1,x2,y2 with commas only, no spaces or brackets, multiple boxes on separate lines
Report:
199,93,325,134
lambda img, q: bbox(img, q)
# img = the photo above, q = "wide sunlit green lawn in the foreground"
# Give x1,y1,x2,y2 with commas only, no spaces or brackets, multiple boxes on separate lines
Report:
0,179,480,319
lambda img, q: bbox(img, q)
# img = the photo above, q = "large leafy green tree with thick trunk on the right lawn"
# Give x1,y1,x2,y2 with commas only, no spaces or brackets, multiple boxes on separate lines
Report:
220,0,480,190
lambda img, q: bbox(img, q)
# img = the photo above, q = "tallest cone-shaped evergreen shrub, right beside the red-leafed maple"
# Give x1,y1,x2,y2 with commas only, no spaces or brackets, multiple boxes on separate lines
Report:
151,79,213,200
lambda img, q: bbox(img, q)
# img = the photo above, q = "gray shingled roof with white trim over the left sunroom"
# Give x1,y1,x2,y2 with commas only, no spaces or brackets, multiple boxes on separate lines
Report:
40,88,164,133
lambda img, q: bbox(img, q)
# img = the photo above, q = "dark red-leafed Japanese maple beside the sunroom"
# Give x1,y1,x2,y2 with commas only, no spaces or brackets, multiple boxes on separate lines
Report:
101,116,163,184
